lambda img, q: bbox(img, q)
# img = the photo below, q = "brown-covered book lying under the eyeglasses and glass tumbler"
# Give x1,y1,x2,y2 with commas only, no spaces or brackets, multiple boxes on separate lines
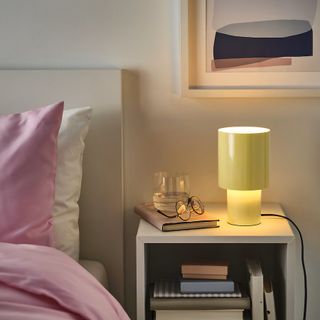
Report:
134,203,219,231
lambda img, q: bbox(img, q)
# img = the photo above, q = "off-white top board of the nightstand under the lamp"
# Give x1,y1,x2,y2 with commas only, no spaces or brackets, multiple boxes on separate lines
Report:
137,203,294,243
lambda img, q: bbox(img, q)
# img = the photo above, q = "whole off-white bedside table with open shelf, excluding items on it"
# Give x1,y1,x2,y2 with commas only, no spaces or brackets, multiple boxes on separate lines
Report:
136,203,296,320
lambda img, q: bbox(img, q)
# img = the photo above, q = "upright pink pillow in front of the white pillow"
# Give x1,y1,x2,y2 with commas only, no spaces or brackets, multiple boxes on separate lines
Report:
0,102,63,246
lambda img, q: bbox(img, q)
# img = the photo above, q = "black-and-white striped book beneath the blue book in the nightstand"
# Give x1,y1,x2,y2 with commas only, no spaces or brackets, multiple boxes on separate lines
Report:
153,280,241,298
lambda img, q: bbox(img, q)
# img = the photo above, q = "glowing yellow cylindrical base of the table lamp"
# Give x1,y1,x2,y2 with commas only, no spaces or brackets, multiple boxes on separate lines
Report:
227,190,261,226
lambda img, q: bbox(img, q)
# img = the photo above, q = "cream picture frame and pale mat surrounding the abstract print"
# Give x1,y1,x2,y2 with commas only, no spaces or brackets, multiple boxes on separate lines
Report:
180,0,320,98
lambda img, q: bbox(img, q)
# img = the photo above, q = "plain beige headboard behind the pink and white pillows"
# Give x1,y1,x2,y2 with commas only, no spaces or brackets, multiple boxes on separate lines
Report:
0,69,124,303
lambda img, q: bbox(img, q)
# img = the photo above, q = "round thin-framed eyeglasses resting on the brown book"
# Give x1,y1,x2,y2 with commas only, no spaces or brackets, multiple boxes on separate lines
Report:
157,196,204,221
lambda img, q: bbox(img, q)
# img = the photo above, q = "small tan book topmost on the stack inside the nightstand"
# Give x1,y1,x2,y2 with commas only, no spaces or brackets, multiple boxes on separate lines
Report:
181,262,228,276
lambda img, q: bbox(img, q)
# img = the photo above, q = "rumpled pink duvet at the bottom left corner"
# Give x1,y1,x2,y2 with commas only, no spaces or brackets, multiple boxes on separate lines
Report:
0,243,129,320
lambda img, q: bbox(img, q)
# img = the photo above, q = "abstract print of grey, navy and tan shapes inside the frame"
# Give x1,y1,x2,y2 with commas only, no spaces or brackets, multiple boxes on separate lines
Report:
207,0,317,71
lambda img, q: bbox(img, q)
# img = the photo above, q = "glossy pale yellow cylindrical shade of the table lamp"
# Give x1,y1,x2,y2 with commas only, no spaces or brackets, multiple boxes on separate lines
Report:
218,127,270,190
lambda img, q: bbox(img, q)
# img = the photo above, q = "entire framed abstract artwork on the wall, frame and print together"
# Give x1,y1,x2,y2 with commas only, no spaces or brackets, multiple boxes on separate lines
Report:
181,0,320,97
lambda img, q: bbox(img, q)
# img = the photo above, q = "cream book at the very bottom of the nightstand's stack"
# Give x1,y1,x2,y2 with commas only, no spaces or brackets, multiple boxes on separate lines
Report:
155,309,243,320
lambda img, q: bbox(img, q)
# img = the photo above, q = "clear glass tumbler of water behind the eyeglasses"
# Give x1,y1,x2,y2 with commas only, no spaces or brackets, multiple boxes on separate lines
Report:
153,171,190,214
